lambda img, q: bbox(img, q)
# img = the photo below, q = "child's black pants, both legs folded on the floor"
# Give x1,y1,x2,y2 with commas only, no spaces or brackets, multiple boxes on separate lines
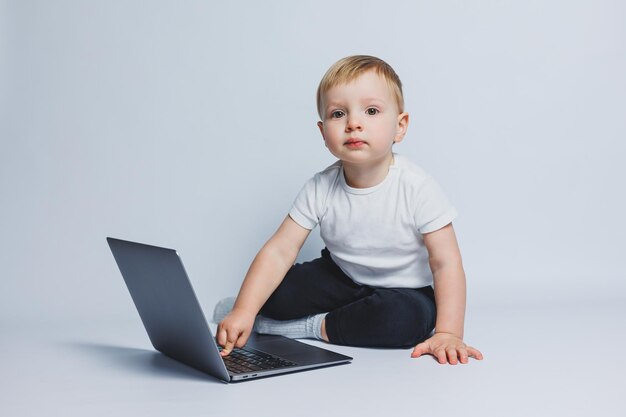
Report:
260,249,436,348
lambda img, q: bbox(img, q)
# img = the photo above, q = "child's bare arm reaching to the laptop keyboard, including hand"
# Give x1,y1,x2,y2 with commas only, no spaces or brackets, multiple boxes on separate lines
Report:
217,216,311,356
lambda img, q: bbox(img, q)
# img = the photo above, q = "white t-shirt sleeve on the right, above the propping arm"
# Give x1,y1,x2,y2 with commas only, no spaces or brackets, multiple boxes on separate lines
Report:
415,177,458,234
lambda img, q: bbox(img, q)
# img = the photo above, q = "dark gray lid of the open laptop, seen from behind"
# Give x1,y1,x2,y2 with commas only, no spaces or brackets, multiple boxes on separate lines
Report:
107,238,230,380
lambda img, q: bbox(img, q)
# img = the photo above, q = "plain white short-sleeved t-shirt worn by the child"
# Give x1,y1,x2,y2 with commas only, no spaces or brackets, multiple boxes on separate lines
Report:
289,154,457,288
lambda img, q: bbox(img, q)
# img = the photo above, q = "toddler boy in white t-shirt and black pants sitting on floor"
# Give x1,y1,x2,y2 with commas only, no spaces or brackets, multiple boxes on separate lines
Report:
215,55,482,364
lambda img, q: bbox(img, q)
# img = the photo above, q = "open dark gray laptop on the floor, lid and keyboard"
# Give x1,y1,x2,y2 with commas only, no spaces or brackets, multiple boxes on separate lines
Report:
107,237,352,382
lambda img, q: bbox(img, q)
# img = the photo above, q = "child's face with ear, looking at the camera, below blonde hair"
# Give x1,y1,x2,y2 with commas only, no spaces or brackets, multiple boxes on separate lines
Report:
318,70,409,164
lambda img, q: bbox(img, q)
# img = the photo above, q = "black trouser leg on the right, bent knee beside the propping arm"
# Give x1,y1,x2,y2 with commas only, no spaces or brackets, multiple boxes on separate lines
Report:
325,287,436,348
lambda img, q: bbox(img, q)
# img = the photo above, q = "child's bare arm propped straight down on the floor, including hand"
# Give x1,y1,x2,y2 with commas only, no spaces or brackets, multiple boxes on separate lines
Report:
411,223,482,365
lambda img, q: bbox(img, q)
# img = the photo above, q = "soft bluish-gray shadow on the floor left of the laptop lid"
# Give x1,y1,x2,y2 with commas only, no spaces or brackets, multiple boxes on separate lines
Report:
69,342,223,384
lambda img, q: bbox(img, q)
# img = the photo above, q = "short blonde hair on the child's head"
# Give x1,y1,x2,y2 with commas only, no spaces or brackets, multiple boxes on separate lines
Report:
317,55,404,119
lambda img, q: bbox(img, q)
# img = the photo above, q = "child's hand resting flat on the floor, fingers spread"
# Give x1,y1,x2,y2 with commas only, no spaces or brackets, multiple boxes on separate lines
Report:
411,333,483,365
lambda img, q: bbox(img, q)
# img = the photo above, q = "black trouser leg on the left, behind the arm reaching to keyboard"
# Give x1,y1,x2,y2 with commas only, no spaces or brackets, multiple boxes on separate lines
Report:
259,249,373,320
